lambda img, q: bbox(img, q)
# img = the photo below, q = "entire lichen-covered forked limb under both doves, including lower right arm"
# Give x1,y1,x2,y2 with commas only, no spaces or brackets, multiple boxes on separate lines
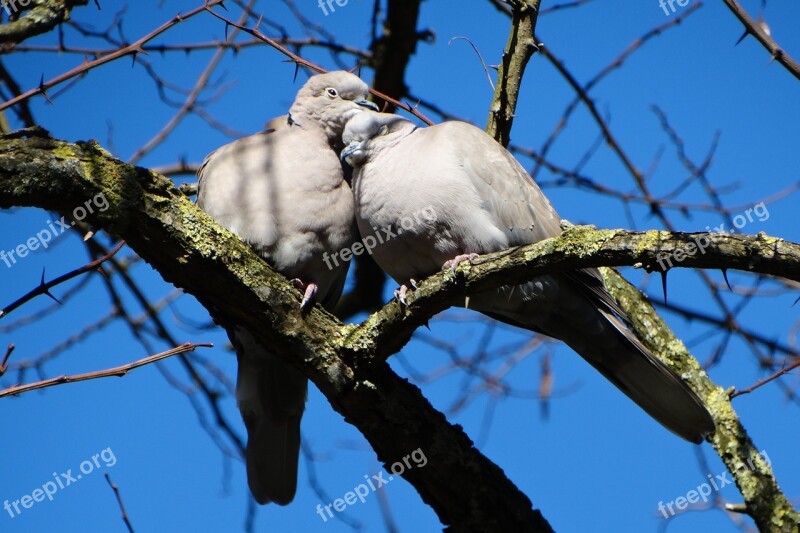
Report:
0,132,800,530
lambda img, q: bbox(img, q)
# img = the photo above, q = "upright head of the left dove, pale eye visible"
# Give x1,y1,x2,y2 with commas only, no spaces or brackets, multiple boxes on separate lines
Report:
289,70,378,146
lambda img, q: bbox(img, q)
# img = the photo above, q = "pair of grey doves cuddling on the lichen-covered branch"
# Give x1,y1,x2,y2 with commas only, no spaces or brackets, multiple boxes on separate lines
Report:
197,71,714,505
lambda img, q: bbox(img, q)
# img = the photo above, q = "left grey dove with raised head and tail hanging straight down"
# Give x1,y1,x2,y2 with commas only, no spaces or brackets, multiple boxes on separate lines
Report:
197,72,375,505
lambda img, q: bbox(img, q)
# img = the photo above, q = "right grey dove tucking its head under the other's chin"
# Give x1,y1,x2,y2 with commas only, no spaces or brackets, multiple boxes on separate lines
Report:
342,111,714,444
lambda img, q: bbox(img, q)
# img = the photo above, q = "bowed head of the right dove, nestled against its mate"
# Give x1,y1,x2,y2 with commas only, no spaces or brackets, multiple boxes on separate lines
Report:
341,111,416,168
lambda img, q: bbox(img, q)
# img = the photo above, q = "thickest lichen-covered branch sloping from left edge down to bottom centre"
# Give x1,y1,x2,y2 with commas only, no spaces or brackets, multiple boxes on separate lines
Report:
0,132,550,531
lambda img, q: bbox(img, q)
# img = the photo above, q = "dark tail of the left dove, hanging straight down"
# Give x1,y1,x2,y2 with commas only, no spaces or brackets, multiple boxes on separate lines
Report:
232,328,308,505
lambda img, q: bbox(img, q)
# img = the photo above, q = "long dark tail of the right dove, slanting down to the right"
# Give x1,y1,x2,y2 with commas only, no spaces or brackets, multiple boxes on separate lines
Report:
470,271,715,444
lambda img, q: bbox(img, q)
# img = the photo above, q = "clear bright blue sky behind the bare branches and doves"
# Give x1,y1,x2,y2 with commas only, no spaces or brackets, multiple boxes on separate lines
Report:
0,0,800,532
